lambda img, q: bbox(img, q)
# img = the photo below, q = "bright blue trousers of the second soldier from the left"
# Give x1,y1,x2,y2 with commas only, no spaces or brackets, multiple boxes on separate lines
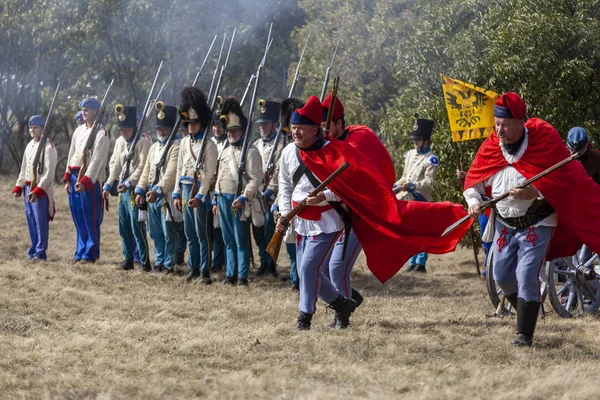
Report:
69,171,104,260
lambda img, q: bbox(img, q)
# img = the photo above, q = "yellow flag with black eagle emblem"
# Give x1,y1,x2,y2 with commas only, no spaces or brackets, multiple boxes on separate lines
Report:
442,75,498,142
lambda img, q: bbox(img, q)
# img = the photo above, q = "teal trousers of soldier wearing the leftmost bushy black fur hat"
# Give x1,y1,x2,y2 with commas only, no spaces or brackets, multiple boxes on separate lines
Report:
182,183,212,271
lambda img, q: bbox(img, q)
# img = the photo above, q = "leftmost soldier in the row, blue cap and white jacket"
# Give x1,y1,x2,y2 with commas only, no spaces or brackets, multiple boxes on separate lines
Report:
13,115,56,260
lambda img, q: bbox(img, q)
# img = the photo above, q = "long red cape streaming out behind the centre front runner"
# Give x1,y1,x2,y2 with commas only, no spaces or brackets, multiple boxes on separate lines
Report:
300,140,472,283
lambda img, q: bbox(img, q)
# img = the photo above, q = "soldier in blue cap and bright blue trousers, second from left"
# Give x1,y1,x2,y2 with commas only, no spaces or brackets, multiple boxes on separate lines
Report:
63,98,109,263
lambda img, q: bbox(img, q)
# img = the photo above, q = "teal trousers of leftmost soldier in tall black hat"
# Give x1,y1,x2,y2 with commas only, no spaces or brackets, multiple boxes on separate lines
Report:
119,188,150,264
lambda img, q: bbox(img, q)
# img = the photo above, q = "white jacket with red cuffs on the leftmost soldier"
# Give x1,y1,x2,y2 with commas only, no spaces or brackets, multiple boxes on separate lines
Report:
15,139,57,219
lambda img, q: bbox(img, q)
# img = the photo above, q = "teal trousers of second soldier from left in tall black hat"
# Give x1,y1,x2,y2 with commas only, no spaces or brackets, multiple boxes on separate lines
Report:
148,198,178,269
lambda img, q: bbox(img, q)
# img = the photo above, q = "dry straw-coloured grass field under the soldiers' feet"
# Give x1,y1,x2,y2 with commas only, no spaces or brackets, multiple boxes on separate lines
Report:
0,177,600,399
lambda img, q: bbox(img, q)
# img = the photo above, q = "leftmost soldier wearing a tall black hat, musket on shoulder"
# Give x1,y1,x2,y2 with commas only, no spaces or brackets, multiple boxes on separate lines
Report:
102,107,152,272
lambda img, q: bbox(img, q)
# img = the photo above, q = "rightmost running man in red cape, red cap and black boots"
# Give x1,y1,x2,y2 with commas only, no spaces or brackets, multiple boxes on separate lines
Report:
464,92,600,346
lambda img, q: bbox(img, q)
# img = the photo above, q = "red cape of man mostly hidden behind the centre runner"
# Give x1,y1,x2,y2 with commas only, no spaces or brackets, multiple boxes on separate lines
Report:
344,125,396,187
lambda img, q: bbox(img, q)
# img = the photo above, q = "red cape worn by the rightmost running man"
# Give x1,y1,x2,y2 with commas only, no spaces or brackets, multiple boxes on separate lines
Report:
465,118,600,260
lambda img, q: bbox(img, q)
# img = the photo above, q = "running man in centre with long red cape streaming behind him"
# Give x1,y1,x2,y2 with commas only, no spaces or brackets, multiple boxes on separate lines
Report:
277,96,471,328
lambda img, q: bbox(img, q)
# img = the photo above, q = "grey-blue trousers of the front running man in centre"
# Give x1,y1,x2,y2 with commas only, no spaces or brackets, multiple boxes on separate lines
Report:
296,232,340,314
